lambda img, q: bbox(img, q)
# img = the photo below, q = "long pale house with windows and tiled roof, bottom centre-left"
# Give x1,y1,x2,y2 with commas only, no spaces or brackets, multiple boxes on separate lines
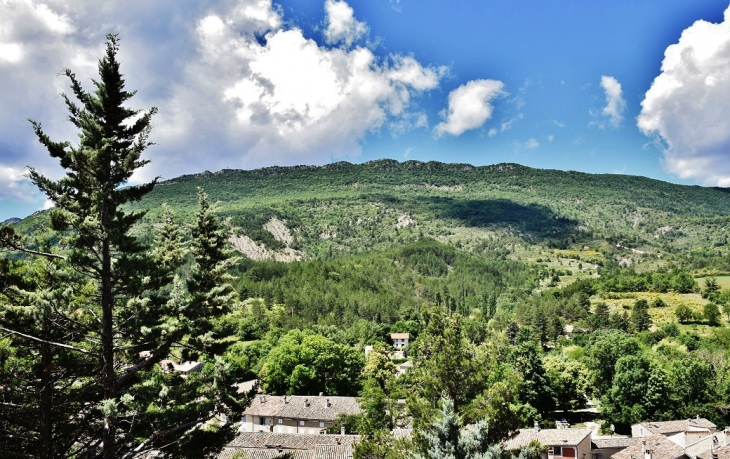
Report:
240,394,360,434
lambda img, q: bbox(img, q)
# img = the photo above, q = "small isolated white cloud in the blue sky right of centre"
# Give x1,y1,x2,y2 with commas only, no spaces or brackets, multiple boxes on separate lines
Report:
434,80,504,137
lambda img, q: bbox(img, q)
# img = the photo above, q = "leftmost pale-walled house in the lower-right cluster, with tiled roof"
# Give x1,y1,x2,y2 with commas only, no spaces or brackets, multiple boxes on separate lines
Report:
502,427,592,459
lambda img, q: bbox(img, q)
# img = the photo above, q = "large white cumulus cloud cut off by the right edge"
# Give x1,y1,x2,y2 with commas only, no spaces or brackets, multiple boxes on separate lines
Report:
637,7,730,186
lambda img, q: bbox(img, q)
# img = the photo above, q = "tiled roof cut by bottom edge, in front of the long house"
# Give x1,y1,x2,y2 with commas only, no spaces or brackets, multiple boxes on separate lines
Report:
218,432,360,459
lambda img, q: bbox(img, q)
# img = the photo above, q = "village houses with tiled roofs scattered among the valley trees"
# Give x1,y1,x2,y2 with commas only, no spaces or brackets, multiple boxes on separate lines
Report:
154,333,730,459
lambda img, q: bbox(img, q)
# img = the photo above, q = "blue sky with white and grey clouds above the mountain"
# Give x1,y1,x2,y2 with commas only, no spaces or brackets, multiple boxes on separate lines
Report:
0,0,730,221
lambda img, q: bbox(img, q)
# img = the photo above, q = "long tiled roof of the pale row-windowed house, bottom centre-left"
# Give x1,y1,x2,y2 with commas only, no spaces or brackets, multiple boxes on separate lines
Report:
244,395,360,421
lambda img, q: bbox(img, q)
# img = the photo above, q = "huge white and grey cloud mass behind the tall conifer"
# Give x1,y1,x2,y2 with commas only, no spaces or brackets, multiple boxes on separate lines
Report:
0,0,446,191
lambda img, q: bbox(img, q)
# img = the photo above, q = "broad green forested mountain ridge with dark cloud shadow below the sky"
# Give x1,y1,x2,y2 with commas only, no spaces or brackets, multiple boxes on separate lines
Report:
112,160,730,268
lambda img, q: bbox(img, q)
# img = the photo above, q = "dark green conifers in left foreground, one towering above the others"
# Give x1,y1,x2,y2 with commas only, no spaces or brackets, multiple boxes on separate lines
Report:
0,35,247,458
